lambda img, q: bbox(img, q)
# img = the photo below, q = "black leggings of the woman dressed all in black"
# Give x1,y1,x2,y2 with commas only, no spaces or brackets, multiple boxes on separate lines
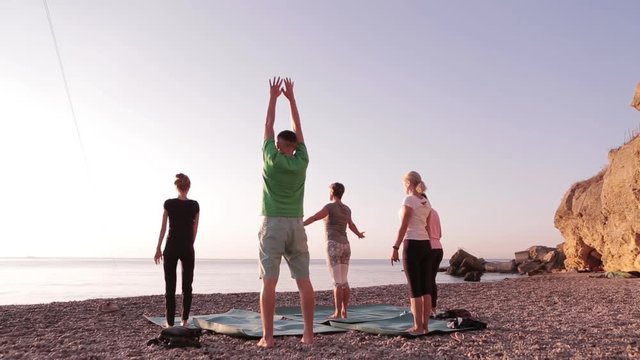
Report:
164,248,195,326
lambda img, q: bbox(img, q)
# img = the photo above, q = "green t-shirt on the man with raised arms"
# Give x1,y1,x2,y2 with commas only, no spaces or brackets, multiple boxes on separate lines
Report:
262,139,309,217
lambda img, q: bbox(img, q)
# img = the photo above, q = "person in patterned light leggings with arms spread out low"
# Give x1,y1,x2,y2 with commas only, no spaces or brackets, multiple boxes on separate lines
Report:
304,183,364,319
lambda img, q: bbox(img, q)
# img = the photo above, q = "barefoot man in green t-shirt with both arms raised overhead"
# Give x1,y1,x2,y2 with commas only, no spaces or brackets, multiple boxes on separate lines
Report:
258,77,315,347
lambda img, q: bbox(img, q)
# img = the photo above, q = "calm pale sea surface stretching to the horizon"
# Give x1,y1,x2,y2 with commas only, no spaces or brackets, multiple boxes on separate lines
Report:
0,258,520,305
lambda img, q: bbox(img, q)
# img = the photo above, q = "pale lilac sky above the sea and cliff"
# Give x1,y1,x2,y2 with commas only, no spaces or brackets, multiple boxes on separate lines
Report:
0,0,640,259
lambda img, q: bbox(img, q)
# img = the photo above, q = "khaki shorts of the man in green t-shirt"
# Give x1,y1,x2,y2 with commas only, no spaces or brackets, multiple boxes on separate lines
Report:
258,216,309,279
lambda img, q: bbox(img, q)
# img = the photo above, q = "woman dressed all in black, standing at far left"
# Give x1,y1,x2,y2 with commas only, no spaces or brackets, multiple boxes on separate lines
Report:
153,174,200,326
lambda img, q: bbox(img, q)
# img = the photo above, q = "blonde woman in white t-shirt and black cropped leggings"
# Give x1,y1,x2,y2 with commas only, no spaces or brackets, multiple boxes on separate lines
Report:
391,171,433,334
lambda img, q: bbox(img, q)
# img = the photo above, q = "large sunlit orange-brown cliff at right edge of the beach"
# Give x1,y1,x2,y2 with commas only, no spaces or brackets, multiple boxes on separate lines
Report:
555,136,640,271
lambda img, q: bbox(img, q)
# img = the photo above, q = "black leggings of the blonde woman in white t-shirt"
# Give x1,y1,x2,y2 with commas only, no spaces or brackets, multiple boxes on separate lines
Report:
402,240,433,298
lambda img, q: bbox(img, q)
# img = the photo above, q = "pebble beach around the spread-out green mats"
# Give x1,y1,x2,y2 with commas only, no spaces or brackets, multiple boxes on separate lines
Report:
0,274,640,359
